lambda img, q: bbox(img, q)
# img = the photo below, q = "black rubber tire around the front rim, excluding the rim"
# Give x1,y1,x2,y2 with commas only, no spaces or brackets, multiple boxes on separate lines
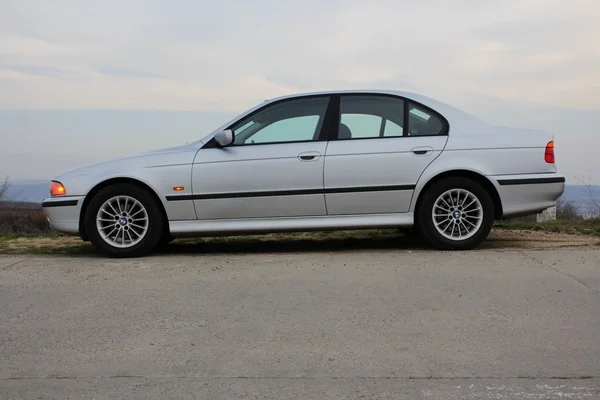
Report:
84,183,165,257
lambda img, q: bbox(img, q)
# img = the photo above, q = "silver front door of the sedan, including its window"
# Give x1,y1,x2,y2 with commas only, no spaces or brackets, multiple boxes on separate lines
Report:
192,96,330,220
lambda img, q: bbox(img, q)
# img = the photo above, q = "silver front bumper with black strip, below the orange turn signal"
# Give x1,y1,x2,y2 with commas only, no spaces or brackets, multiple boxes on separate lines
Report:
42,196,83,235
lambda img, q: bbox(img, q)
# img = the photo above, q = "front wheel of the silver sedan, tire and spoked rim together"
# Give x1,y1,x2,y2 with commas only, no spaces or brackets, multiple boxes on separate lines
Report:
85,183,165,258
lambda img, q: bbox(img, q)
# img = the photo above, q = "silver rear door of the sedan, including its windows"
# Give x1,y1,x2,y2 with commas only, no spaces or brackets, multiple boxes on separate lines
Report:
324,94,448,215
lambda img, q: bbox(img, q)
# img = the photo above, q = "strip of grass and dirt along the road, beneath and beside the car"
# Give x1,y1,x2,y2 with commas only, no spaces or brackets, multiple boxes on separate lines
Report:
0,229,600,255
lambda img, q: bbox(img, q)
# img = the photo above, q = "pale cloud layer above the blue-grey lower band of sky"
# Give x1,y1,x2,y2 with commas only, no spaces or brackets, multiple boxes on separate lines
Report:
0,0,600,111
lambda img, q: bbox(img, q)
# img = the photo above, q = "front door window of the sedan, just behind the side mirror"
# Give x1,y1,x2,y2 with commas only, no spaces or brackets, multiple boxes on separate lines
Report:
231,97,329,145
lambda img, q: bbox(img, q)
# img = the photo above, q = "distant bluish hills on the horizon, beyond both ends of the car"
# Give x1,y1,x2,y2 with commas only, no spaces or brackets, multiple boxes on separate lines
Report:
8,181,600,214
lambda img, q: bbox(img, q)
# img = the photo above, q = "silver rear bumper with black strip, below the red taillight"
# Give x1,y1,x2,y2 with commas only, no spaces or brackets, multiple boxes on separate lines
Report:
489,173,565,218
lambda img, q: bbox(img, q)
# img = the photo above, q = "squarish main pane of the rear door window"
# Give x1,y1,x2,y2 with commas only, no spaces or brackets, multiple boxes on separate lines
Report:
339,95,404,139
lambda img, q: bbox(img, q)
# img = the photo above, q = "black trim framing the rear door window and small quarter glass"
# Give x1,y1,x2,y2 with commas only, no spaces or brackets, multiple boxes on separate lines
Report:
330,92,450,141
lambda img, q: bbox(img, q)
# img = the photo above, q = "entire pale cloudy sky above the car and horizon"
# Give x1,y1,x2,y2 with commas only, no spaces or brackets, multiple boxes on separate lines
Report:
0,0,600,184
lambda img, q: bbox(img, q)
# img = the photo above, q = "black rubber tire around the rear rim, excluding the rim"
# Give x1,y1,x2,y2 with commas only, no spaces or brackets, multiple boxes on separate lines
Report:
417,177,494,250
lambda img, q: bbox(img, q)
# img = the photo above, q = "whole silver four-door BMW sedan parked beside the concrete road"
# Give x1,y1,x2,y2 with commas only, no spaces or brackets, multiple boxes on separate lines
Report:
42,90,565,257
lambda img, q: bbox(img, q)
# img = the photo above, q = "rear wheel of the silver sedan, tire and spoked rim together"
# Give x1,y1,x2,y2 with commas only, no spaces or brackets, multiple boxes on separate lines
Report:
417,177,494,250
